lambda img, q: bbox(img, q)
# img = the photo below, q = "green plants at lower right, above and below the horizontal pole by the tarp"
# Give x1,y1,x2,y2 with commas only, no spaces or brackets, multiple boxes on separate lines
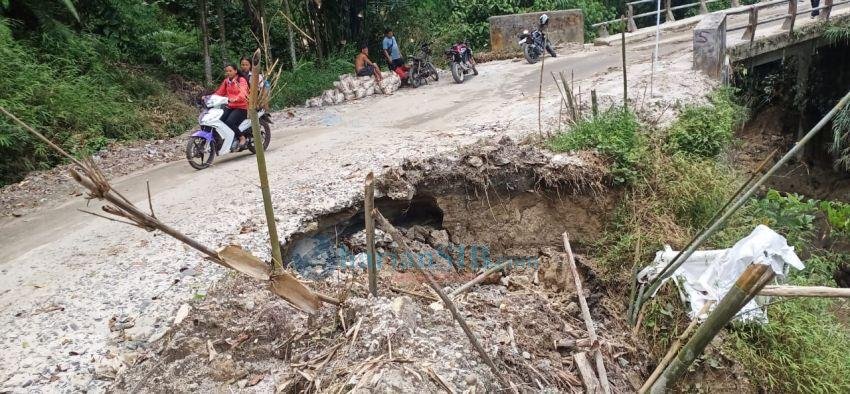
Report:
717,190,850,393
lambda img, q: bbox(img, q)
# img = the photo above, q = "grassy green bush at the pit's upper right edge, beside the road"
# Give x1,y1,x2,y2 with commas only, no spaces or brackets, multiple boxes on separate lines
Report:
547,109,646,184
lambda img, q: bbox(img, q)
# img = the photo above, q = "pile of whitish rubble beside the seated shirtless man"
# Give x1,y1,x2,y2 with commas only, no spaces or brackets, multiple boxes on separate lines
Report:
304,71,401,107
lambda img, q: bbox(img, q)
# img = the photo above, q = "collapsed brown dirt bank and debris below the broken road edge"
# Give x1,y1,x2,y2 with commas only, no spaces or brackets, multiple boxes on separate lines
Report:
114,139,647,392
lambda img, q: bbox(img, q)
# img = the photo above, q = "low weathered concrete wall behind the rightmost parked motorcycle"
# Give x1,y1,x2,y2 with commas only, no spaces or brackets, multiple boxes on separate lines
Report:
489,10,584,52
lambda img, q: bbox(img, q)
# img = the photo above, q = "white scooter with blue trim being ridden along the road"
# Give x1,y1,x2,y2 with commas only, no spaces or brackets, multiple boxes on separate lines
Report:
186,95,272,170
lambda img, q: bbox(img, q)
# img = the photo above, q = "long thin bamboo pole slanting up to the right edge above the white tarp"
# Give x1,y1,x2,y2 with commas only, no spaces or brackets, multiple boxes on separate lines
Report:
641,91,850,301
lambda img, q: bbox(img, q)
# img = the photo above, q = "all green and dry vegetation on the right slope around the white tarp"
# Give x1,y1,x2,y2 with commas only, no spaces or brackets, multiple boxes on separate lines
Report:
547,90,850,393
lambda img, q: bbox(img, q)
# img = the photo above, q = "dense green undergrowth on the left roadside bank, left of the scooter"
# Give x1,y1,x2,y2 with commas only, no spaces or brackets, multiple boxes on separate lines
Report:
0,19,192,184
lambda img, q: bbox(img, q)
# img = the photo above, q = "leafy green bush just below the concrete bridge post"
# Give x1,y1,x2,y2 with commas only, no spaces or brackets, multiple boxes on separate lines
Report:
667,89,745,158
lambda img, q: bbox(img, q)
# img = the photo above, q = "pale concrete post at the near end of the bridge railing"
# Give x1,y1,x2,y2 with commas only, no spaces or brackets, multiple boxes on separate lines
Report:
694,12,726,78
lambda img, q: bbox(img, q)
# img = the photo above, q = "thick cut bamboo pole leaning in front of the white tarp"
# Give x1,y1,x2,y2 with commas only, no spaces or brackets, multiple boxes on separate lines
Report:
649,264,774,394
